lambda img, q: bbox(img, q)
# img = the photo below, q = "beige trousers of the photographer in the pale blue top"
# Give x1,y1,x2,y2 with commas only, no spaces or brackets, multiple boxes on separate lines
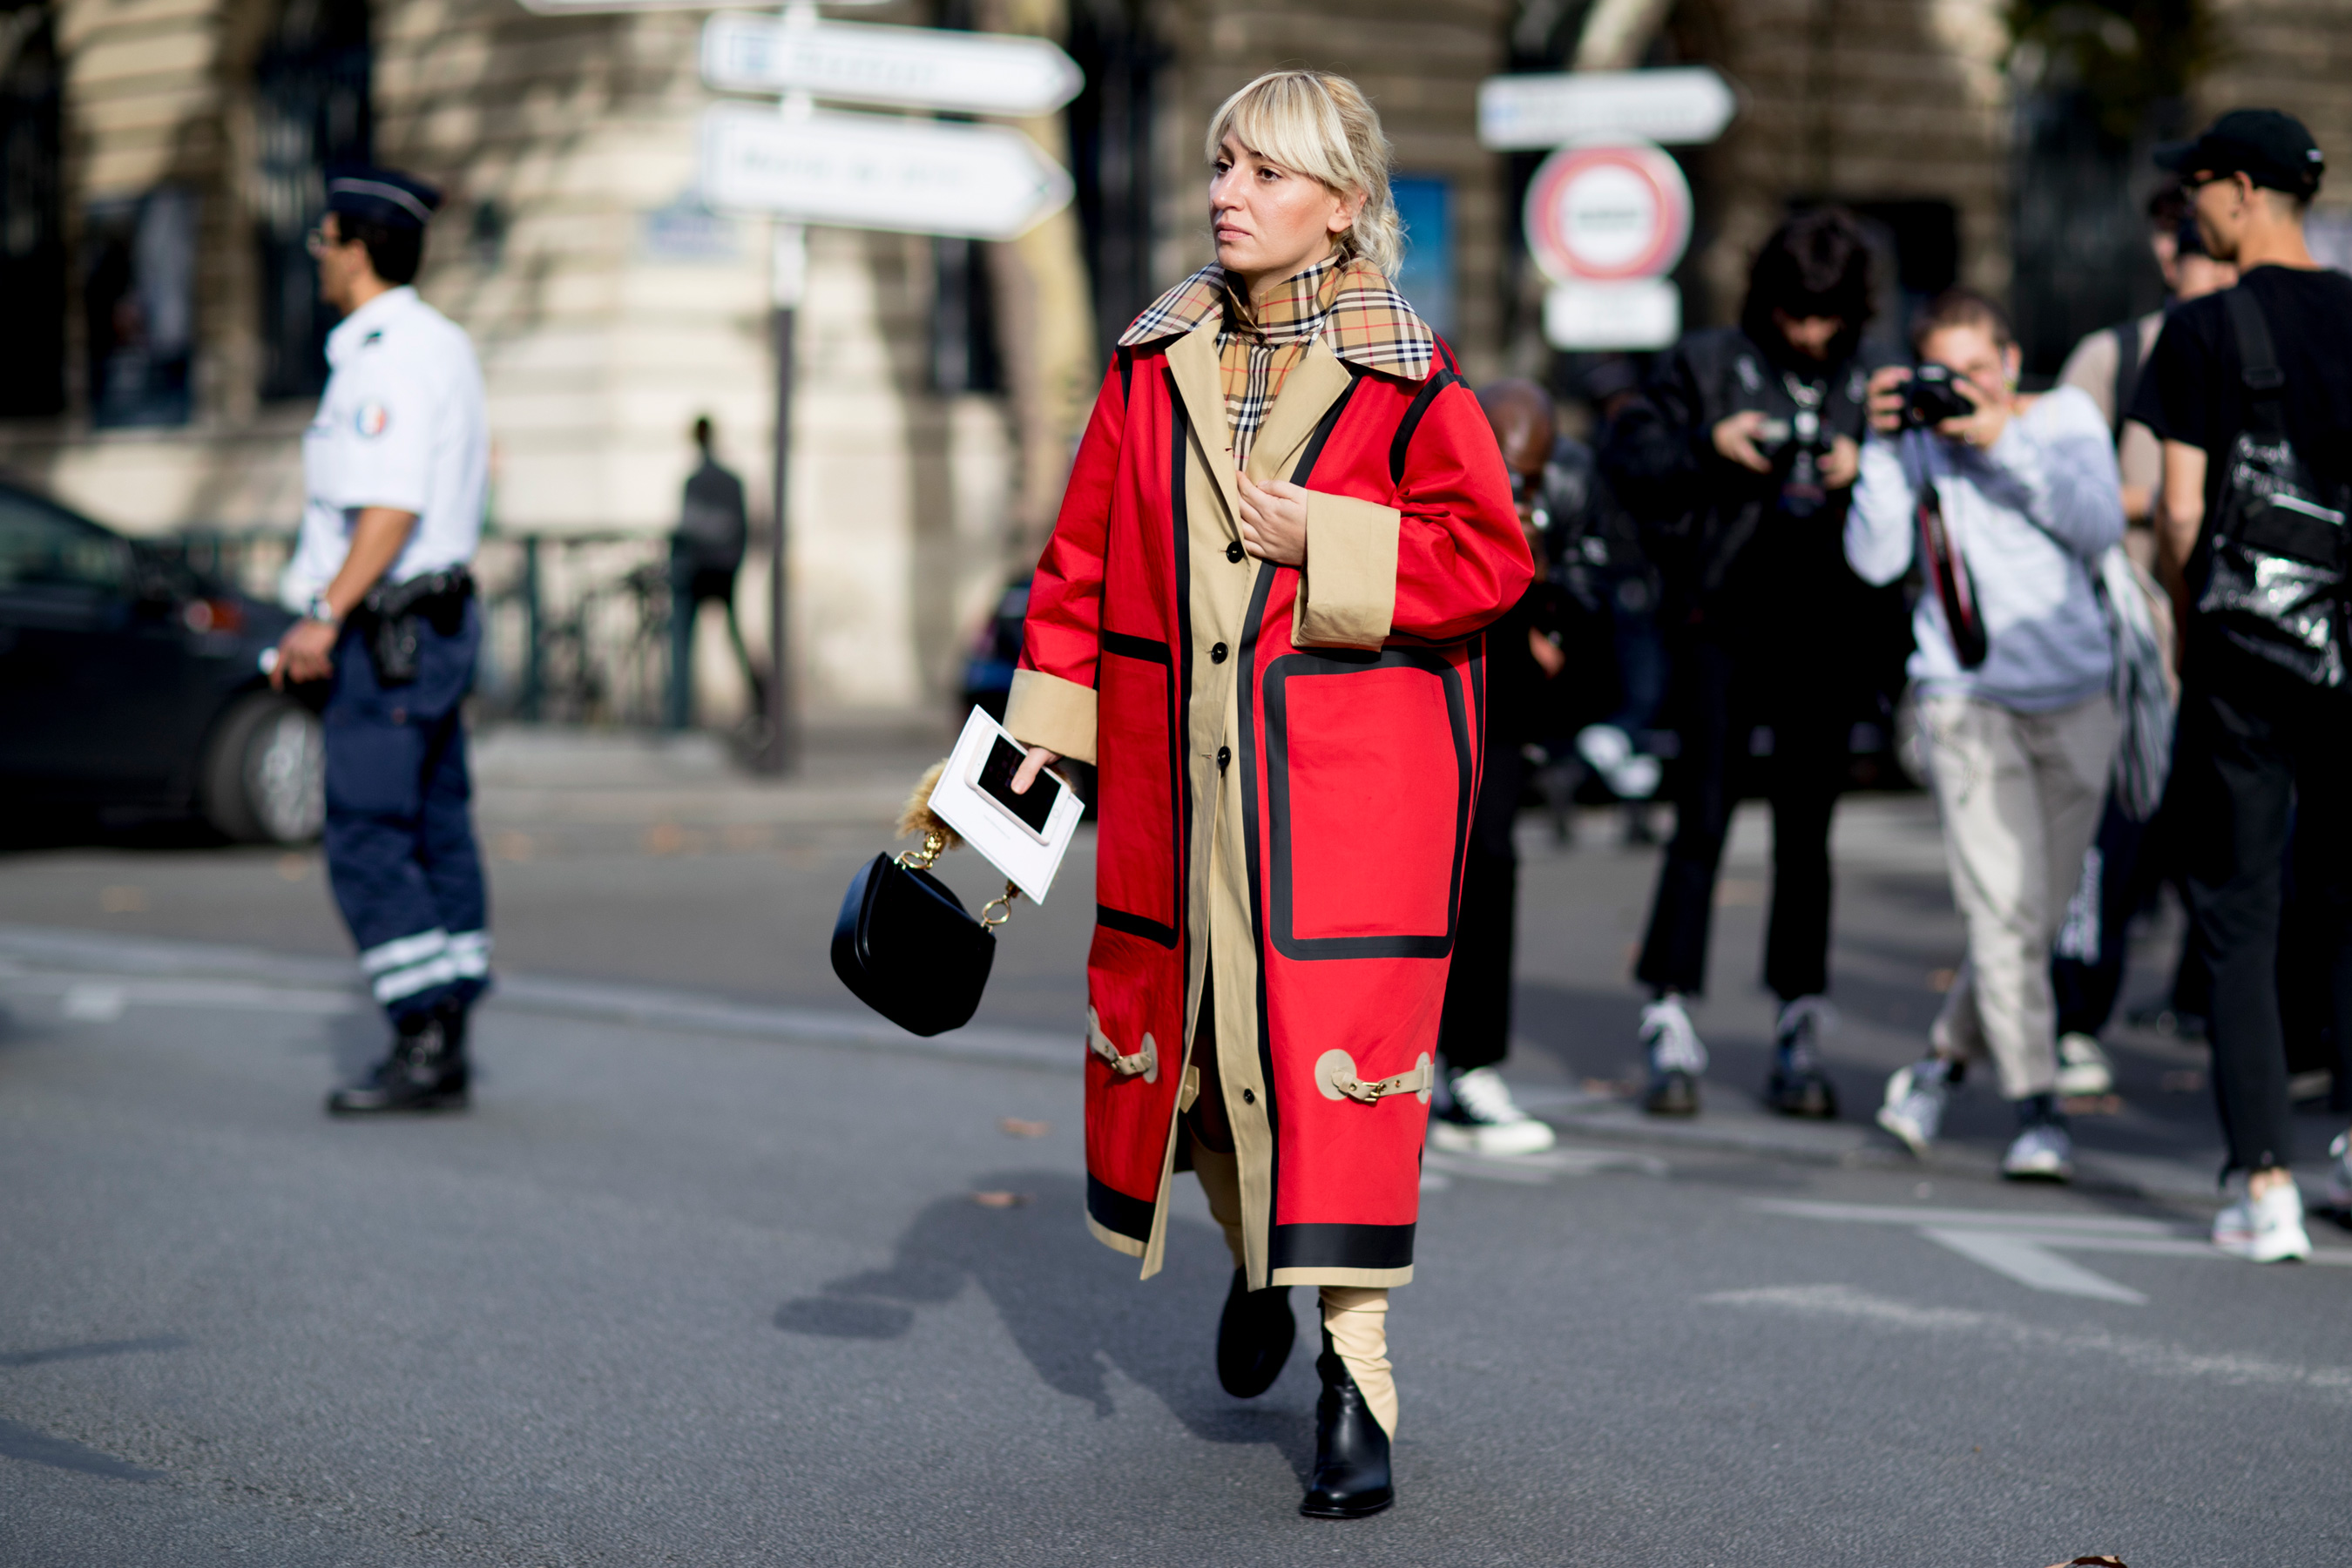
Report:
1919,693,2121,1100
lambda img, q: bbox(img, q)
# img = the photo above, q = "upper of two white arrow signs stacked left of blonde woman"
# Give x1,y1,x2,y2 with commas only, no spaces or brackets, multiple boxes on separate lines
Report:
703,17,1086,115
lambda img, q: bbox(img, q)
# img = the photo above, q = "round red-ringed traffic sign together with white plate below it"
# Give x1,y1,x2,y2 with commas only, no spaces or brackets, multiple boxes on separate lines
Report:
1522,139,1691,348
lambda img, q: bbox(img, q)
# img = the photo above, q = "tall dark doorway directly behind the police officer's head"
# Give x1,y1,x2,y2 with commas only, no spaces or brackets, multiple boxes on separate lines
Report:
254,0,374,397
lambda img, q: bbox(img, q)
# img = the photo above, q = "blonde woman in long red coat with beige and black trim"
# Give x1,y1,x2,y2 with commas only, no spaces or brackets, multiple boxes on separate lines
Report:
1007,71,1531,1518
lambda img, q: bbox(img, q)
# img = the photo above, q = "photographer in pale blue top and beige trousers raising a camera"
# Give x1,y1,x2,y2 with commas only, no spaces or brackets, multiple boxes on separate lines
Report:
1847,289,2124,1180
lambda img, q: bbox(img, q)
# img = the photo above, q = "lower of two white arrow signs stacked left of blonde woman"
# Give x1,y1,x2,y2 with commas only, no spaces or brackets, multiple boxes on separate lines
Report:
701,105,1071,240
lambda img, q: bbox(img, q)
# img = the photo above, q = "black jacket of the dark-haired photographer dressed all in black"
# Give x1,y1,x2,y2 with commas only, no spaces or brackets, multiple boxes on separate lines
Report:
1602,327,1872,635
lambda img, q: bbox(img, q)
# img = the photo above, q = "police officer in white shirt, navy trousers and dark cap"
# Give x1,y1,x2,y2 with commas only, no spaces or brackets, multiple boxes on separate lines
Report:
271,167,490,1114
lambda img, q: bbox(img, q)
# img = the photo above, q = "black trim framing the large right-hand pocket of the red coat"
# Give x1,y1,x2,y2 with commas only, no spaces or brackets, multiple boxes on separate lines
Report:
1263,649,1477,963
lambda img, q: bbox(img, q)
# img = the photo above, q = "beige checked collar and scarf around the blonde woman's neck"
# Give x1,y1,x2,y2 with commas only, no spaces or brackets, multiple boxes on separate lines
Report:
1119,256,1437,463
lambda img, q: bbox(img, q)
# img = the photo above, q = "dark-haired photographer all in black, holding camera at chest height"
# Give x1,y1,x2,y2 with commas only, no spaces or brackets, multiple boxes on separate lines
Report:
1602,209,1872,1117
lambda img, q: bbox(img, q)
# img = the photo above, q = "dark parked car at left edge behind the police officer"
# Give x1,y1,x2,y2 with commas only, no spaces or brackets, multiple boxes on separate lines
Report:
0,482,325,844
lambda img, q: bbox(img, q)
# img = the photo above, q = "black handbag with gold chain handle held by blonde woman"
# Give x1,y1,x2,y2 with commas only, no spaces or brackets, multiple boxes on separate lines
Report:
833,832,1018,1034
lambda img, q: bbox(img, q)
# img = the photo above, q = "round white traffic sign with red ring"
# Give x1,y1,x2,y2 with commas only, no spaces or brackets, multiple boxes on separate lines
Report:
1522,137,1691,282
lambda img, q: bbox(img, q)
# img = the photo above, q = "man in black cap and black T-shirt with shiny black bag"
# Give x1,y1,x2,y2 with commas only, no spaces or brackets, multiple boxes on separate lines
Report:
2131,108,2352,1262
